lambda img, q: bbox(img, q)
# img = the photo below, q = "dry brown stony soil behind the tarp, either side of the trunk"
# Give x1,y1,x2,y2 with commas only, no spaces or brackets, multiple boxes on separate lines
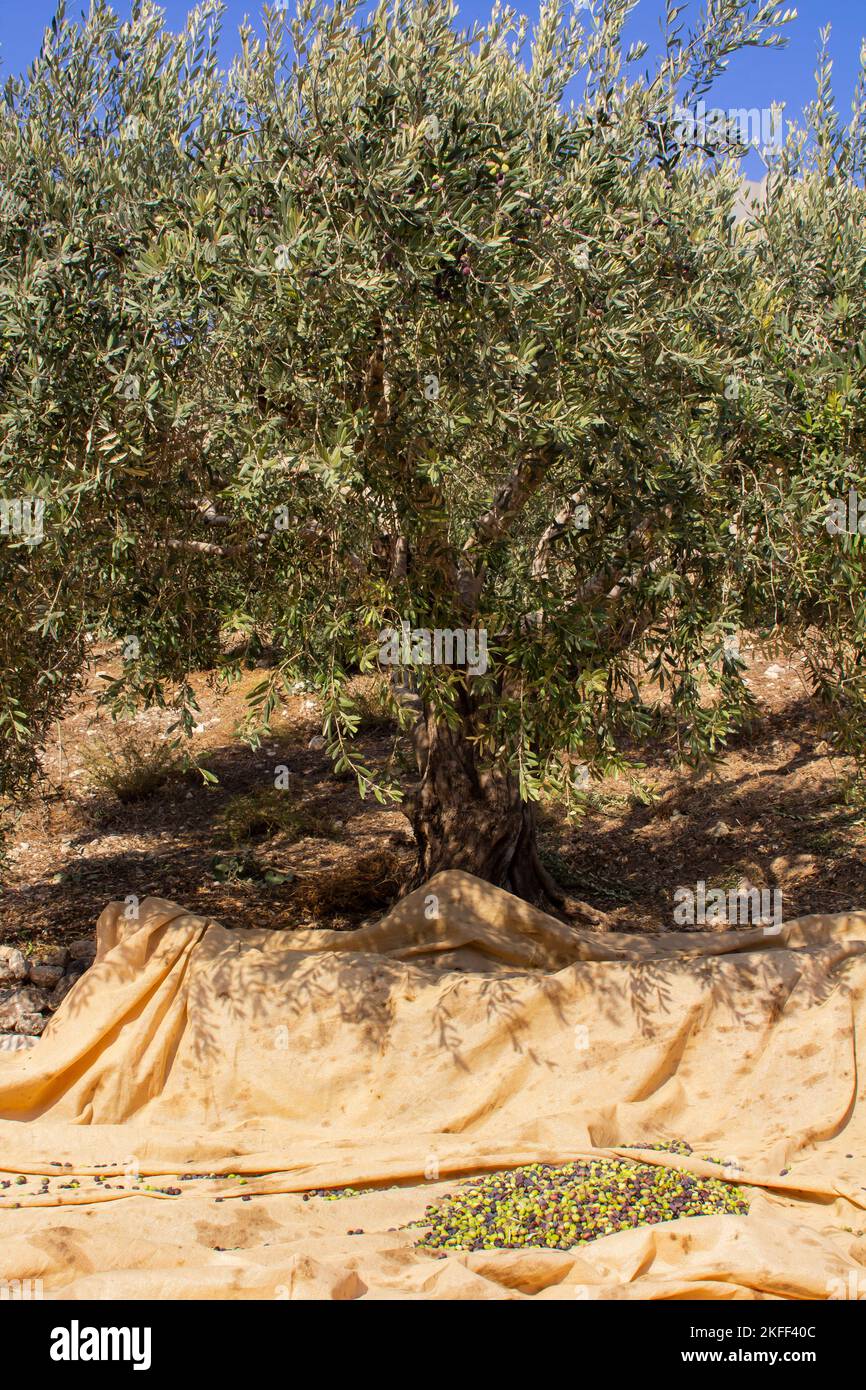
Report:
0,642,866,949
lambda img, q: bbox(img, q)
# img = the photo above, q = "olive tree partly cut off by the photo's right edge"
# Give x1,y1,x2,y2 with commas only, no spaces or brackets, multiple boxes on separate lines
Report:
735,31,866,778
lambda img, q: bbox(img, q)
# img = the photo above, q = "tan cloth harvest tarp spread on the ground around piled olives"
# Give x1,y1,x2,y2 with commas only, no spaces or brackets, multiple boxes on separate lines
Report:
0,873,866,1298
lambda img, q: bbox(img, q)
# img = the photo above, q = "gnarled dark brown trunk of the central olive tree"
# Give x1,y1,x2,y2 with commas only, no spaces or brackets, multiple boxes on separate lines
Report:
411,710,592,910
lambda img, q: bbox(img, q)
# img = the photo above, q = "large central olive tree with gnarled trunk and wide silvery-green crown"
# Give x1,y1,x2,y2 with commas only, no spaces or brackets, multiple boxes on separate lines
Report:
0,0,863,901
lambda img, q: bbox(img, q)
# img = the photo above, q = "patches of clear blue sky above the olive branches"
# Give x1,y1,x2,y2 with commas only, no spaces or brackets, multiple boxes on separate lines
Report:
0,0,866,174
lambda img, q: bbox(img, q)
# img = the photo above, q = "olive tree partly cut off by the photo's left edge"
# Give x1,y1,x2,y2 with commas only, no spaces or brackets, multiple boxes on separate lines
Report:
0,4,225,798
